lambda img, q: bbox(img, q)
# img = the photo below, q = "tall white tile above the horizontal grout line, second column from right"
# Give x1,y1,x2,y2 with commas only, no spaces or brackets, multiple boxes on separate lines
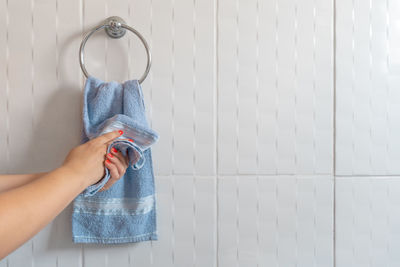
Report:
218,0,333,174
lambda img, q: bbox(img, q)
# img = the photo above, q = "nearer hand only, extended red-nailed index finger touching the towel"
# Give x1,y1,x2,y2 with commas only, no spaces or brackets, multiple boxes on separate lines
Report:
62,130,123,187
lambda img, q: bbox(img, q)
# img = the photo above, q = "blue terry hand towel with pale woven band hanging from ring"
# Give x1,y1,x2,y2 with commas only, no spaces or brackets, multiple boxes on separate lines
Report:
72,76,158,244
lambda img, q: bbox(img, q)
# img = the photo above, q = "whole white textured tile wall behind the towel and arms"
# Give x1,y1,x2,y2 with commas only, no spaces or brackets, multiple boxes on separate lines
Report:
0,0,400,267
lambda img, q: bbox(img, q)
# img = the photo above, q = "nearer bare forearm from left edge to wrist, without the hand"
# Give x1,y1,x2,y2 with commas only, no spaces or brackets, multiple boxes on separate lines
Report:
0,167,88,259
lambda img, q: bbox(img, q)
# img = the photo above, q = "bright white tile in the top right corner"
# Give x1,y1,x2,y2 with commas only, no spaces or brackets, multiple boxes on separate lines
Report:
336,0,400,175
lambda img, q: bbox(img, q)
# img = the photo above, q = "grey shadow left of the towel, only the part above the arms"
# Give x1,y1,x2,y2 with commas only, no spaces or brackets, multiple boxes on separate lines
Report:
11,30,82,173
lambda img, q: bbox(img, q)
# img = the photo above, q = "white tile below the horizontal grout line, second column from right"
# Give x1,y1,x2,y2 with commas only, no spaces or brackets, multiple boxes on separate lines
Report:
218,176,333,266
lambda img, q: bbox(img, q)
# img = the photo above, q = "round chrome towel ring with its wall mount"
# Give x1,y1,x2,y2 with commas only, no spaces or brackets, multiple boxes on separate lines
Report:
79,16,151,83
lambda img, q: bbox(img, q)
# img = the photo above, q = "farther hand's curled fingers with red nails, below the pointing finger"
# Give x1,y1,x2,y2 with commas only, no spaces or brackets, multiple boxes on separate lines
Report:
100,147,129,191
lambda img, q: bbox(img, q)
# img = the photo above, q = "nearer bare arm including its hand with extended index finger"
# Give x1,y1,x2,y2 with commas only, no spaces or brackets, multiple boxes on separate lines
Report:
0,131,120,259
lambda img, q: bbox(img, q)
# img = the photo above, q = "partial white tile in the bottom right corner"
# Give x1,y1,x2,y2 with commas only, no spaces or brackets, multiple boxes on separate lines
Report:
336,177,400,266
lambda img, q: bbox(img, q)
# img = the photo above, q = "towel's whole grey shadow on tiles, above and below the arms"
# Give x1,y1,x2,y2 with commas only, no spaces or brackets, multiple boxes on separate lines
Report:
19,28,140,256
